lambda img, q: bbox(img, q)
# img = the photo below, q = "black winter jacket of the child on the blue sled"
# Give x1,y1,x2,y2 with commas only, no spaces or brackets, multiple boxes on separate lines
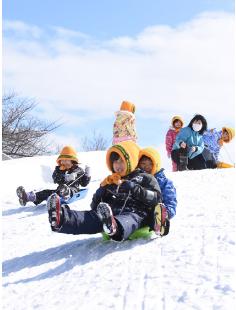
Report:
52,164,91,194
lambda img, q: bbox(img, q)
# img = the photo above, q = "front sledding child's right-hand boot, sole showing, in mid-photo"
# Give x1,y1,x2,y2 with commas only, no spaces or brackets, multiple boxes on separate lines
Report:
97,202,117,236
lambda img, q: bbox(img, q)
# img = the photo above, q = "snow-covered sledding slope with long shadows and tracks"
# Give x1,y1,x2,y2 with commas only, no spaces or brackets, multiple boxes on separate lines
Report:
2,152,235,310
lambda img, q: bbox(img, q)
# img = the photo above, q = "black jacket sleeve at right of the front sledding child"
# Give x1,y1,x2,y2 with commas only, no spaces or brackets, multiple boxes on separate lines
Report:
131,173,161,207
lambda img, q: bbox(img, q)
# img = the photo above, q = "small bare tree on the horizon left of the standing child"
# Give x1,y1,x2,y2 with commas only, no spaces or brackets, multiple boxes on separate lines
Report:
82,130,108,152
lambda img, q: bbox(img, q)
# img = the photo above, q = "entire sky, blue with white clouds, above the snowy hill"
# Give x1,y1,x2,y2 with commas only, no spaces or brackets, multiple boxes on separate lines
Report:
2,0,234,167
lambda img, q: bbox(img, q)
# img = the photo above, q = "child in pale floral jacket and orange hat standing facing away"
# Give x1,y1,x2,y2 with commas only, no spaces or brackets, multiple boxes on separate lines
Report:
112,101,137,144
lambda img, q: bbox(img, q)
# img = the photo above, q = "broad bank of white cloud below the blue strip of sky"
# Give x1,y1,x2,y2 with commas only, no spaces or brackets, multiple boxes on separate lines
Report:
3,13,234,130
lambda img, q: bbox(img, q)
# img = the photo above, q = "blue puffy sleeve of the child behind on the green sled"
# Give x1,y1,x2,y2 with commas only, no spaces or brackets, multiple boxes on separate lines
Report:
161,178,177,219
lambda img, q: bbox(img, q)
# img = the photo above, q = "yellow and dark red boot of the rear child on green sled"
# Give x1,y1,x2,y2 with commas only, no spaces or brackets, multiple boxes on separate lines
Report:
154,203,170,237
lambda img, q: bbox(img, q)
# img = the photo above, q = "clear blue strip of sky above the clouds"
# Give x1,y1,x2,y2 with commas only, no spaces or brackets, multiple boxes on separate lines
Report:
2,0,234,39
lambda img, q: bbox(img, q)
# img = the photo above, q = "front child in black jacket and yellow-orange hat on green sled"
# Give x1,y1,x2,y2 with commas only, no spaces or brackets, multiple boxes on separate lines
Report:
48,141,161,241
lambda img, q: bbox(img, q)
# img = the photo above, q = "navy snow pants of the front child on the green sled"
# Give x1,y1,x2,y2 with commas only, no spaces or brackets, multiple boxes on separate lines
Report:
58,205,145,241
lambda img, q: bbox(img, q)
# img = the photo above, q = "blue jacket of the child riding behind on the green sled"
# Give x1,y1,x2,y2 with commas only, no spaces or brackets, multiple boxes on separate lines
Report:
154,168,177,219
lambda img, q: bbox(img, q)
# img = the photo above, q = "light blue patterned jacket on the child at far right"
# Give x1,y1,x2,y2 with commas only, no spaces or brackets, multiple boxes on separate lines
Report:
203,128,222,161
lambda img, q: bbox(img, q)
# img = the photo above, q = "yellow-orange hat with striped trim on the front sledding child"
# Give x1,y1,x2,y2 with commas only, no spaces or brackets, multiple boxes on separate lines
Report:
106,140,140,176
